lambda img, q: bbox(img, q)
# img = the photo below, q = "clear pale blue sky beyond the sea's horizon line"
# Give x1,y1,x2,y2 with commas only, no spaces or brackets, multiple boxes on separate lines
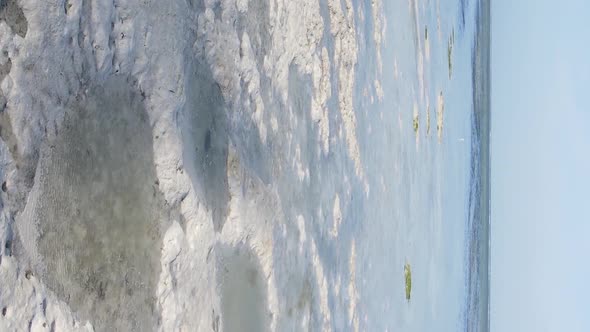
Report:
490,0,590,332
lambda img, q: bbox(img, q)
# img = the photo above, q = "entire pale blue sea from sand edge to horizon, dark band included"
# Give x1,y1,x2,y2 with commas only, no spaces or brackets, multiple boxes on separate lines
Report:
351,0,490,331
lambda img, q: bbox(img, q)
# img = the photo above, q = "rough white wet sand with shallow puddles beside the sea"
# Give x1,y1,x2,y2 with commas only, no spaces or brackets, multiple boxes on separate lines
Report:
0,0,372,331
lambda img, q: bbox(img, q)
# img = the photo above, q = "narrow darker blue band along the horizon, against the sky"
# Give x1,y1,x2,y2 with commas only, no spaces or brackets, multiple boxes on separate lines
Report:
465,0,491,331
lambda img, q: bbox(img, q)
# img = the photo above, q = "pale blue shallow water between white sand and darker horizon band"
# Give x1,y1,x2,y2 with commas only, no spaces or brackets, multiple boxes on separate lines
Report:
344,0,488,331
